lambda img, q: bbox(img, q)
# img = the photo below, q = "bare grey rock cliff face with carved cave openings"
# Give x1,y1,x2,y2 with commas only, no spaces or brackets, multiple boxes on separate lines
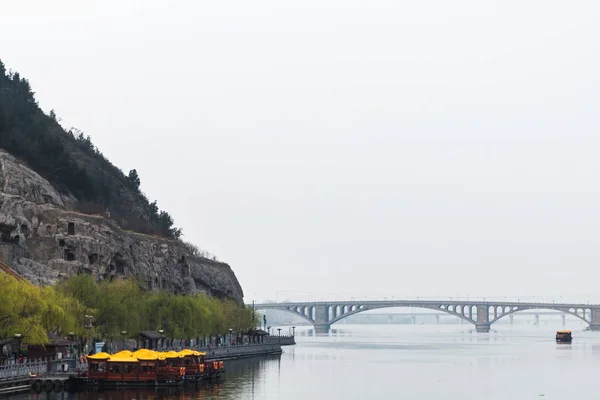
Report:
0,149,243,303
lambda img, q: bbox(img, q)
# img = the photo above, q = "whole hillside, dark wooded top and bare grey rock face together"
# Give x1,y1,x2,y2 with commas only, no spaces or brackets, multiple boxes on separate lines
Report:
0,62,243,303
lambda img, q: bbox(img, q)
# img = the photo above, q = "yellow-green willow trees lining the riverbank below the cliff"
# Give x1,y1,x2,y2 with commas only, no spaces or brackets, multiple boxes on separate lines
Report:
0,274,252,344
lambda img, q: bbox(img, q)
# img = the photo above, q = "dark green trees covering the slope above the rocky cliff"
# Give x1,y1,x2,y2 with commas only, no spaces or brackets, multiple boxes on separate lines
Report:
0,60,181,239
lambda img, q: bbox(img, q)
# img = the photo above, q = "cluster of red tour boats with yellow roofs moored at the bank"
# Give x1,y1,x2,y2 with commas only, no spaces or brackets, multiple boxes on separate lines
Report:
71,349,225,388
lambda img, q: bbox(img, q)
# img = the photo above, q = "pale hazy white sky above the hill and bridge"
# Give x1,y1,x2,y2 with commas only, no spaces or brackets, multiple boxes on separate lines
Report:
0,0,600,303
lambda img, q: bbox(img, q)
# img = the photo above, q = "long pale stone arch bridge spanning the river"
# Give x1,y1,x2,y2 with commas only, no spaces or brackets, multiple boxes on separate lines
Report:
254,300,600,333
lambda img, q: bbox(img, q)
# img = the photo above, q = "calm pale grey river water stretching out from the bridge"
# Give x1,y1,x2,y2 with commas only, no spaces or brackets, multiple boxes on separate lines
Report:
12,324,600,400
